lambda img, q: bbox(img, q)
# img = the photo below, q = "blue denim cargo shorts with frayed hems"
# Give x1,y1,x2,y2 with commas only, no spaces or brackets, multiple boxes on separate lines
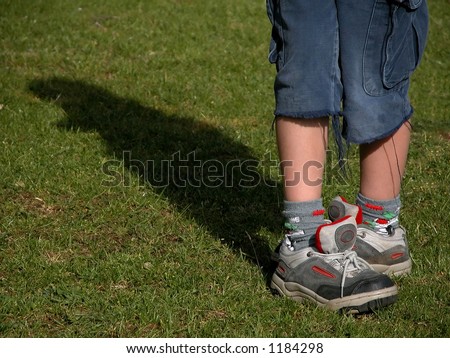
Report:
267,0,428,144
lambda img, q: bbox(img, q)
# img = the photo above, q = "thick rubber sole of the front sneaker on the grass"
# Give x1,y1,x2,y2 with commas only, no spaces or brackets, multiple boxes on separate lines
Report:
270,273,398,314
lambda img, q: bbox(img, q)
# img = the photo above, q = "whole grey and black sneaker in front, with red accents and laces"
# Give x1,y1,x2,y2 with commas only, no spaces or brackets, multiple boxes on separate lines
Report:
270,216,397,313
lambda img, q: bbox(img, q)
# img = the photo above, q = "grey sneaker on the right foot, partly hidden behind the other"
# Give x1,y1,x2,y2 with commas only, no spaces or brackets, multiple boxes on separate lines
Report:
328,196,412,276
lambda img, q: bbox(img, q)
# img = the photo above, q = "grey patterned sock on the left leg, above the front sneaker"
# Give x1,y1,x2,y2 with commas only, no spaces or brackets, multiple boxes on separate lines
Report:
283,199,325,250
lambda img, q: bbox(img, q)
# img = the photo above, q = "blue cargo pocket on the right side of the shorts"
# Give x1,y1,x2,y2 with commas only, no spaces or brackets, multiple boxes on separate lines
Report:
364,0,428,96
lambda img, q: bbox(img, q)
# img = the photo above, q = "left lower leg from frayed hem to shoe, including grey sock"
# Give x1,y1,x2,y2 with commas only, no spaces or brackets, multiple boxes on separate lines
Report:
276,117,328,250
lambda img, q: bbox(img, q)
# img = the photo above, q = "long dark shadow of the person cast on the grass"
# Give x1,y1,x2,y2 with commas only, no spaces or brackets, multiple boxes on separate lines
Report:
29,78,280,279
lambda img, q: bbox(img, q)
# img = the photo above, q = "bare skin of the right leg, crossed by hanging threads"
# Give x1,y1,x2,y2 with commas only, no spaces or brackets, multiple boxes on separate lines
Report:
360,122,411,201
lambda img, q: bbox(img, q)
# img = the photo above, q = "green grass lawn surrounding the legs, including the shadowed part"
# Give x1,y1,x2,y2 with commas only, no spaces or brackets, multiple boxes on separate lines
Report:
0,0,450,337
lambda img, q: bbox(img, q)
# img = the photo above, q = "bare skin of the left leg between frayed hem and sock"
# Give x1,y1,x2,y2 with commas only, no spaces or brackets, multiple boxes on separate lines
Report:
276,117,329,202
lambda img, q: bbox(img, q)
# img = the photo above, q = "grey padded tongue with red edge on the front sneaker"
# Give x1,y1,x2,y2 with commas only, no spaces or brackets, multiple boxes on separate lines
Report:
316,215,356,254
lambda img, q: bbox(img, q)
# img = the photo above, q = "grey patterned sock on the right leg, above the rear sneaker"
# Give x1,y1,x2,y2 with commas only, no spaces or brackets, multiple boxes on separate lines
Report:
356,193,401,235
